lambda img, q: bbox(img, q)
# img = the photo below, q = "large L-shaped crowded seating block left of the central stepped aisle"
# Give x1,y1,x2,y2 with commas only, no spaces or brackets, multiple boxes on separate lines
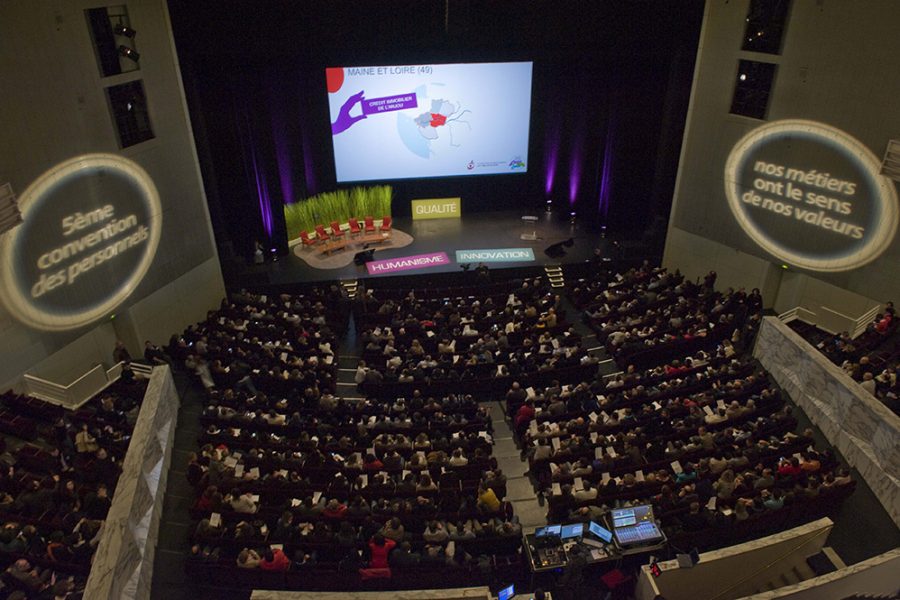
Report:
174,290,521,589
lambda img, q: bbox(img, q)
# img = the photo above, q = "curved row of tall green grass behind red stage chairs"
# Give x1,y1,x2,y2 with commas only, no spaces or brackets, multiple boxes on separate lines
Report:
284,185,393,240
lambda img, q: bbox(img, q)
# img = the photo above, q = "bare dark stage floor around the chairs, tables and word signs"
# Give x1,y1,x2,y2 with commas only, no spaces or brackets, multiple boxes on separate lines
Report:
230,211,611,285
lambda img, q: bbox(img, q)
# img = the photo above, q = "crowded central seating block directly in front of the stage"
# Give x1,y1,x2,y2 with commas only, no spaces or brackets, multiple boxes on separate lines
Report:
356,278,596,399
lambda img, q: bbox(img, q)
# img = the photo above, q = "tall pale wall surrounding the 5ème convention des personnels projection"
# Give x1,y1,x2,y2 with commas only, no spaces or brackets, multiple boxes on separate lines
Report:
0,0,224,385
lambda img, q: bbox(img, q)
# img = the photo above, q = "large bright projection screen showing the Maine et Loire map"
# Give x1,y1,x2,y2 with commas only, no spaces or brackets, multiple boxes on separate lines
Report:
326,62,532,182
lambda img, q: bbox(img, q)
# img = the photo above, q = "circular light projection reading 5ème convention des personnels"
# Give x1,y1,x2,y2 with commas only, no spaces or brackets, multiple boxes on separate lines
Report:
0,154,162,331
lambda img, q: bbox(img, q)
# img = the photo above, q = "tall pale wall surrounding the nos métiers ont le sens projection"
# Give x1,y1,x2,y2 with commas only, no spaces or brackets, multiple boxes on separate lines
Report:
664,0,900,316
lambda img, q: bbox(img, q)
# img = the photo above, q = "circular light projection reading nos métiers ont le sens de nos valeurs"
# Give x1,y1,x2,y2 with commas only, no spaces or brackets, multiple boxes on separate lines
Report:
725,119,898,272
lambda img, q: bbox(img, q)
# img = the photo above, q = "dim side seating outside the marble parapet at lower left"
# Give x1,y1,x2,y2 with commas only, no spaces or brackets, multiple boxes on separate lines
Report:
0,378,146,599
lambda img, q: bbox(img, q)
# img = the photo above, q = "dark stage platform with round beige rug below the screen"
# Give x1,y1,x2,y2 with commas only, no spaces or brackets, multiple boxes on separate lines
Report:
223,210,623,287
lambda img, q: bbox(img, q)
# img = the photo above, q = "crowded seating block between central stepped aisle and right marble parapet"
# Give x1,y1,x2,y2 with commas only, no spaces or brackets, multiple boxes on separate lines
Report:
506,264,855,549
